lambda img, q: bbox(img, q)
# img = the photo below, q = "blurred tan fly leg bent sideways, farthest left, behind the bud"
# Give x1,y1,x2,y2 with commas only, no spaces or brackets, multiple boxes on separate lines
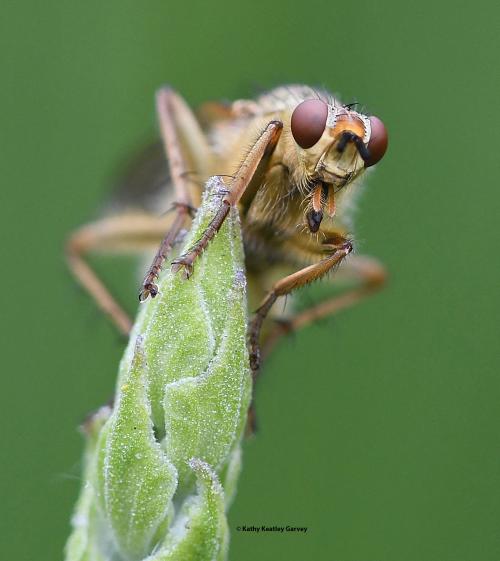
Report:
66,209,177,335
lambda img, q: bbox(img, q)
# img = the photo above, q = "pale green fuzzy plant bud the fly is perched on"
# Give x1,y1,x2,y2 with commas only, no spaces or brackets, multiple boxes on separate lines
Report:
66,178,251,561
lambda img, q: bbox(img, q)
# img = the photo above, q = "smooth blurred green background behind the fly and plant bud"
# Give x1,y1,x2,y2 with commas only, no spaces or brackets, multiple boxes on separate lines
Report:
0,0,500,561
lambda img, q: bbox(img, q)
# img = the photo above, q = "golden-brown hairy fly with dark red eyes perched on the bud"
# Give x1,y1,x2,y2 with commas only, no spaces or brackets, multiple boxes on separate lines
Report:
67,85,387,372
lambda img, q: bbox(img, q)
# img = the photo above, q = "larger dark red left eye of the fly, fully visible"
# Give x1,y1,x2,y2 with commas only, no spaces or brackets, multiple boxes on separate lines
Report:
292,99,328,149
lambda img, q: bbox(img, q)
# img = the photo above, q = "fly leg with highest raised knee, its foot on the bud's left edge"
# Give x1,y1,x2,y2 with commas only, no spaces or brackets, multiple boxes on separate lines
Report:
139,87,212,302
